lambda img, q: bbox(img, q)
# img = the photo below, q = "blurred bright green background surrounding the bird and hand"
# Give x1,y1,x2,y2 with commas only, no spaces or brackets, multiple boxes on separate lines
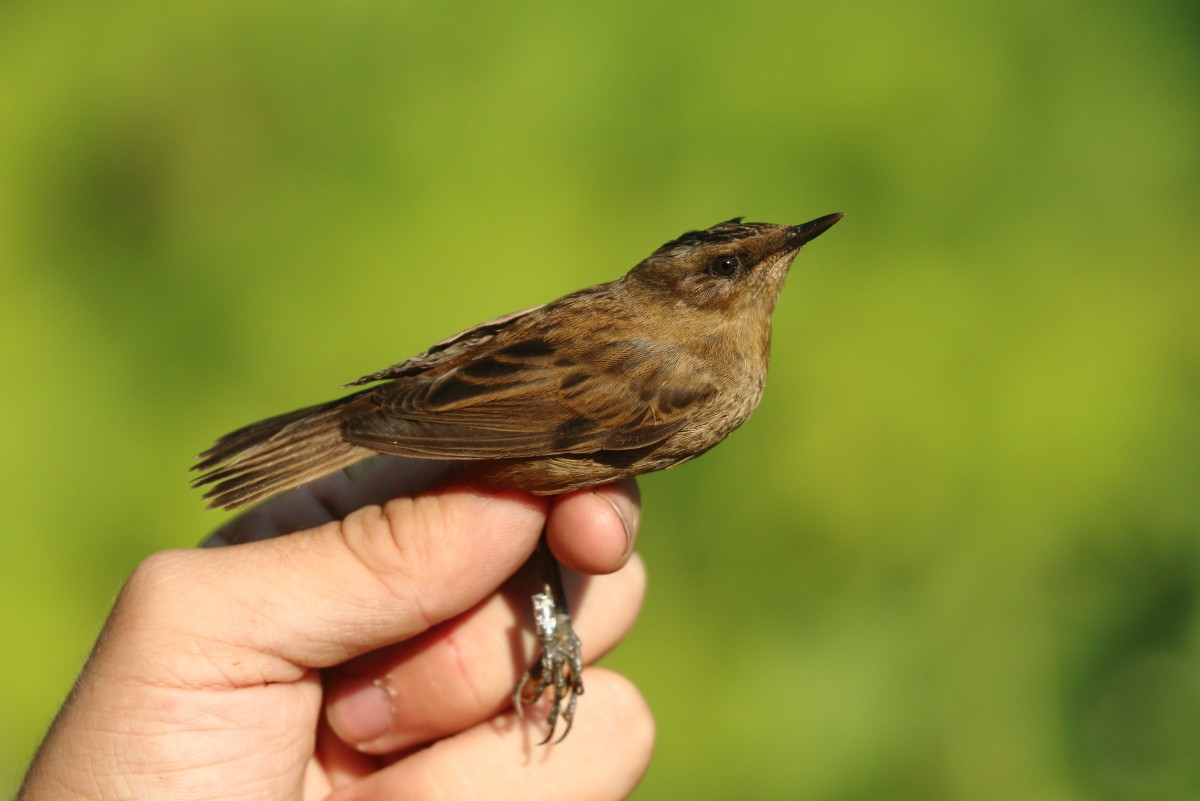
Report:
0,0,1200,801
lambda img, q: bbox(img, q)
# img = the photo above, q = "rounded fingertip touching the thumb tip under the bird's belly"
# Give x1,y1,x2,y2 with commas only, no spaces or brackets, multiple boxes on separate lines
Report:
546,478,642,574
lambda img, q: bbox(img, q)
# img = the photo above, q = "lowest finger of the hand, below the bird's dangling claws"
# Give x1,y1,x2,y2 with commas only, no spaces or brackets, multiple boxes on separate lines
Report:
329,668,654,801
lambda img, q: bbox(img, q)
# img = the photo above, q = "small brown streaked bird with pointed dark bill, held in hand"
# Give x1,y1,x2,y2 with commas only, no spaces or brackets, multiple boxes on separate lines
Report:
193,213,841,740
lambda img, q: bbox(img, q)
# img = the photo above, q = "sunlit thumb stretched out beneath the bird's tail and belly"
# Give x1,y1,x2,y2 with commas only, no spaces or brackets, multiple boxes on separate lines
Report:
115,487,547,686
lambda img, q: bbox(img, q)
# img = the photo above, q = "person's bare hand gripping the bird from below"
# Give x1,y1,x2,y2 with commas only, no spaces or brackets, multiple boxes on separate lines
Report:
18,459,654,801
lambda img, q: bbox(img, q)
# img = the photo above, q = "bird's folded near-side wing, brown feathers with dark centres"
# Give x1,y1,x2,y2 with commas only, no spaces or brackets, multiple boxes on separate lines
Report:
342,332,716,459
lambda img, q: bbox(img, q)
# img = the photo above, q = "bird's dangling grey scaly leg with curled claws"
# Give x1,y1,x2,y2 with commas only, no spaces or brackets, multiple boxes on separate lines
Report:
512,535,583,745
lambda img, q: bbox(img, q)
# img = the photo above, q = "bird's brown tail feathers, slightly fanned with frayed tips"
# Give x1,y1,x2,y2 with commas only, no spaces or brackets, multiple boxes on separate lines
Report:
192,392,374,508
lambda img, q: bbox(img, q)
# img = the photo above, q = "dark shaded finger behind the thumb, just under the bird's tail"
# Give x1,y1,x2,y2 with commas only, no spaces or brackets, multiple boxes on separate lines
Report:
200,456,458,548
